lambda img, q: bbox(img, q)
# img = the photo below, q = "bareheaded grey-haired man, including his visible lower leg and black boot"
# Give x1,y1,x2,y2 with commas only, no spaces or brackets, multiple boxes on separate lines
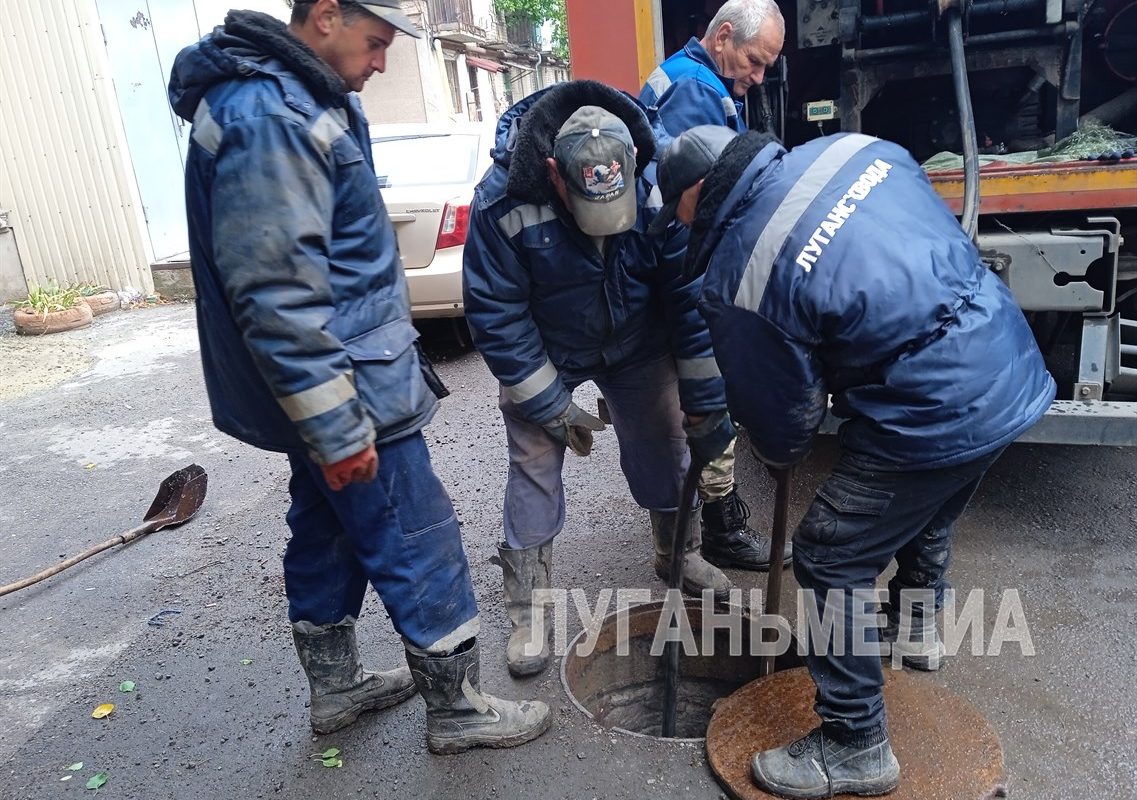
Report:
640,0,789,569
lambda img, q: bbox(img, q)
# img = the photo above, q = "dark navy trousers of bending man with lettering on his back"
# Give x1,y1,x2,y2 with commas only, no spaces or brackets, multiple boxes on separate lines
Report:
794,449,1003,747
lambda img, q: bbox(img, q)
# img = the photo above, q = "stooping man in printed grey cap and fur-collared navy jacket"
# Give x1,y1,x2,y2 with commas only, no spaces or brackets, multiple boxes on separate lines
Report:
464,81,750,675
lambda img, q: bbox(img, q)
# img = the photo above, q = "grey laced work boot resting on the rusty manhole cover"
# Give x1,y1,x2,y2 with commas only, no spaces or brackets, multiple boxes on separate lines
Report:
750,727,901,800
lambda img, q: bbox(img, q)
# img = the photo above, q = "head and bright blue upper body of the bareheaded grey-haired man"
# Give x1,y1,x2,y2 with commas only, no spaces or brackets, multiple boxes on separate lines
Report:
639,0,786,141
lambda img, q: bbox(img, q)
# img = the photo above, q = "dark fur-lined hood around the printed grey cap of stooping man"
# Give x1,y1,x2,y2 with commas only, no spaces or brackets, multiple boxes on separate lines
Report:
492,81,655,205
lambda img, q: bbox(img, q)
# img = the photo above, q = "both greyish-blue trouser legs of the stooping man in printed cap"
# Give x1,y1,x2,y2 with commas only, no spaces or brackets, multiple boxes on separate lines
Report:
499,355,690,549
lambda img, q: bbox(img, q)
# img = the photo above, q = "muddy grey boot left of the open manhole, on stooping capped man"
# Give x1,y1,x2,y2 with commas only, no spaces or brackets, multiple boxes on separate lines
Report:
493,542,553,677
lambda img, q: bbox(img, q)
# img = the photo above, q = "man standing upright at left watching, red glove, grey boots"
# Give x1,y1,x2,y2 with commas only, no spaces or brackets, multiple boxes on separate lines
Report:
169,0,550,753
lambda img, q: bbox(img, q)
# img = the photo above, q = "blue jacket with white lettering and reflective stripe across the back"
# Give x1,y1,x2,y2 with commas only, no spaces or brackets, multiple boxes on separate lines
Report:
700,134,1055,468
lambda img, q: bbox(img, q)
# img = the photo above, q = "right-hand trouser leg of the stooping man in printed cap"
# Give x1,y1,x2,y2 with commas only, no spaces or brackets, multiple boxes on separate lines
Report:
596,356,690,511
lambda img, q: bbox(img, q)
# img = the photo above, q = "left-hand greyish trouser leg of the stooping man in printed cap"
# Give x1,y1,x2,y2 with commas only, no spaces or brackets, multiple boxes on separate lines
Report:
498,389,565,550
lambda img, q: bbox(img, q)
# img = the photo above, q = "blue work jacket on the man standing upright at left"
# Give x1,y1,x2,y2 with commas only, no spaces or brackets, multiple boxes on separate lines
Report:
169,11,438,464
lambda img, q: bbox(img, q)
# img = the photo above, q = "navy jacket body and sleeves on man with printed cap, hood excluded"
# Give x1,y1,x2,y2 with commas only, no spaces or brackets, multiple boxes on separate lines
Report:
463,90,727,424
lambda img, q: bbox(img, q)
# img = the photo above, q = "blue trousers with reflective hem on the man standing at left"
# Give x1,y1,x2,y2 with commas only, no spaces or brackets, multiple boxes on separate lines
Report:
284,433,478,653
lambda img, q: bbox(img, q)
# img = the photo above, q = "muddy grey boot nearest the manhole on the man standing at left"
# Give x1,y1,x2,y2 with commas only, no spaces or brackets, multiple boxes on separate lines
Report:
407,639,553,755
